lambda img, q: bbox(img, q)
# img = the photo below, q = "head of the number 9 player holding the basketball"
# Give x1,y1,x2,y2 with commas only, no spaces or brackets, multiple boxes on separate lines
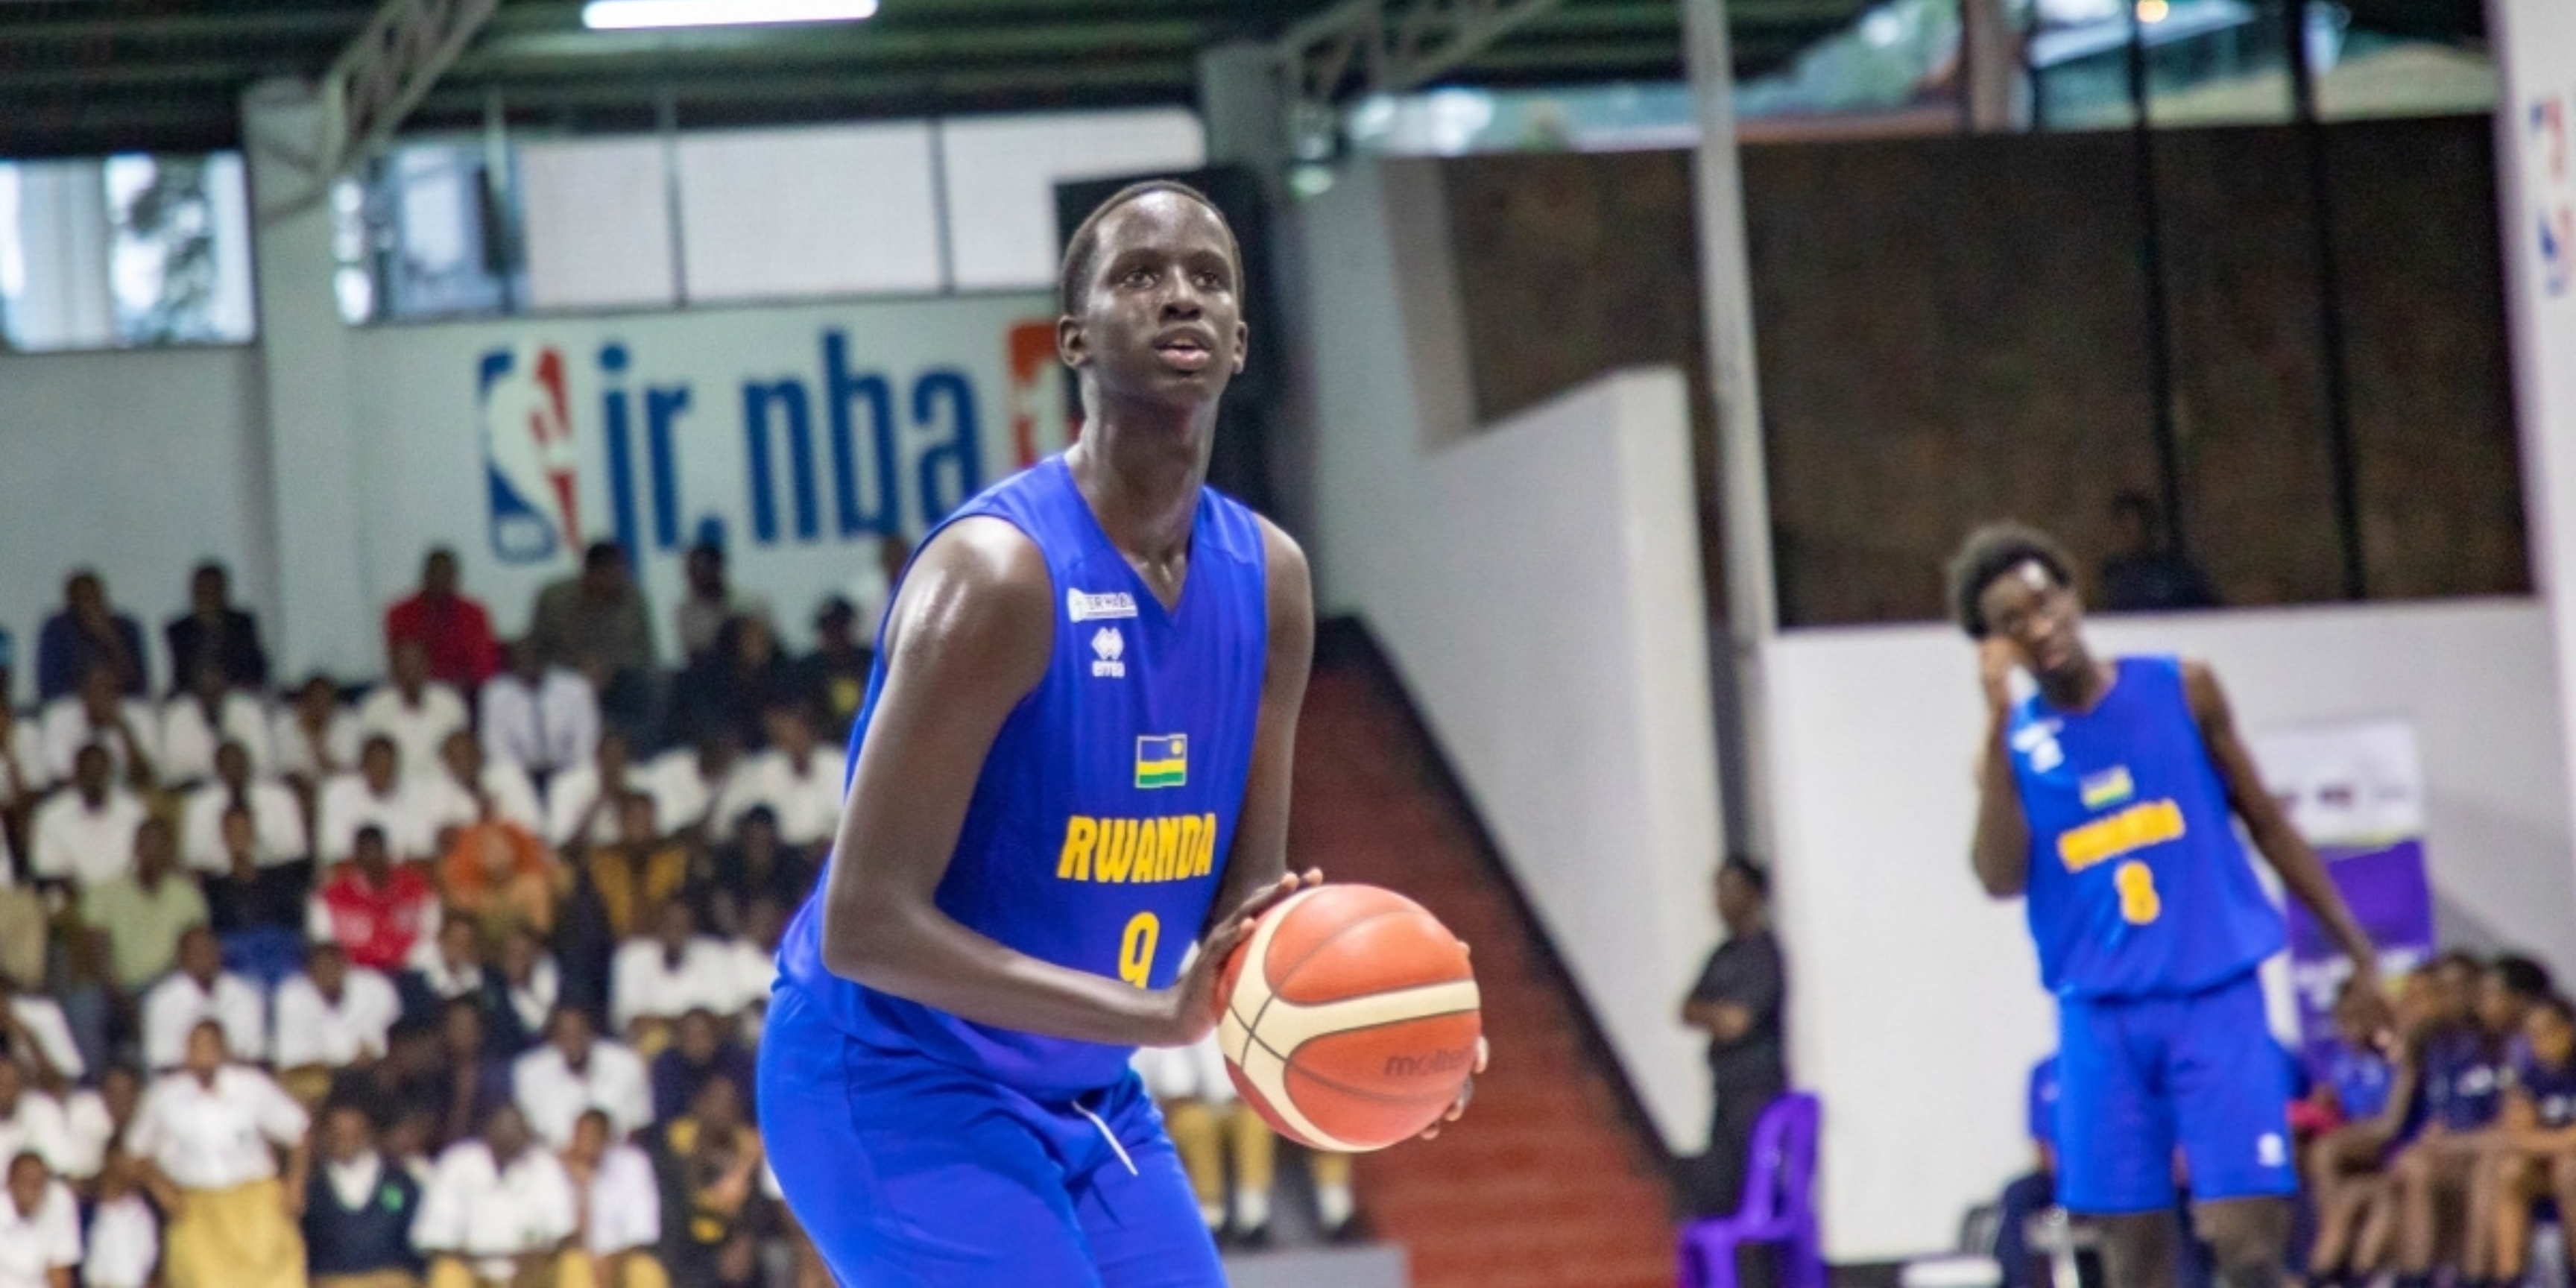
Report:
1056,180,1247,423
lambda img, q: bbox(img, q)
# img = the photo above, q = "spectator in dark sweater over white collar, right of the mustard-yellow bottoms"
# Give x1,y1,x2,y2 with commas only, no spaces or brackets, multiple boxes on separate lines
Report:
304,1102,423,1288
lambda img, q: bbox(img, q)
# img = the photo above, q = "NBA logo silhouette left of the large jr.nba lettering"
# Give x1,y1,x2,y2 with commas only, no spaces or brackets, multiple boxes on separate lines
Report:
474,345,582,564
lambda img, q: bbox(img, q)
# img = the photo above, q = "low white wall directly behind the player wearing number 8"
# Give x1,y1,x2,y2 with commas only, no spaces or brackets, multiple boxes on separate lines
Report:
1770,600,2576,1260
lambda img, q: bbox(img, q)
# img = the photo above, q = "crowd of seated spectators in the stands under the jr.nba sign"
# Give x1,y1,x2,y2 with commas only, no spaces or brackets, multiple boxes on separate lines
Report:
0,543,874,1288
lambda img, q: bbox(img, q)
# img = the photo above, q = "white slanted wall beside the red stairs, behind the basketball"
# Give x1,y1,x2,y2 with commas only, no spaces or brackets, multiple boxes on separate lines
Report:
1298,162,1718,1149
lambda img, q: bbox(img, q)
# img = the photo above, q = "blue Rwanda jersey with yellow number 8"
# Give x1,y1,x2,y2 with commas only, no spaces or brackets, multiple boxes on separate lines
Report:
2007,657,2285,997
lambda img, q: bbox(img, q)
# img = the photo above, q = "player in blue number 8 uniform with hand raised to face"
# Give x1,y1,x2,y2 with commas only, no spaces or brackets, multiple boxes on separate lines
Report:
1950,525,2388,1288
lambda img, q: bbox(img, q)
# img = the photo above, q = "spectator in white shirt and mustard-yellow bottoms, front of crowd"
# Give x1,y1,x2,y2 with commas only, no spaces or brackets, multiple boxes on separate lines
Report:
131,1020,312,1288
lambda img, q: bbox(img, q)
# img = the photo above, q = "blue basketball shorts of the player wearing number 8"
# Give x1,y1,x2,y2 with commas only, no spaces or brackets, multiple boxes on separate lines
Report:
2056,971,2298,1216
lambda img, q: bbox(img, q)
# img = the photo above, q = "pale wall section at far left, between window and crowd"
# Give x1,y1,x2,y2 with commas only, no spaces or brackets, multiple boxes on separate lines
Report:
0,348,271,701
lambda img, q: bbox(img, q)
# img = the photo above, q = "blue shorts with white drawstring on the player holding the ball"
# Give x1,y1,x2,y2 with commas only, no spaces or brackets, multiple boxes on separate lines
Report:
760,987,1226,1288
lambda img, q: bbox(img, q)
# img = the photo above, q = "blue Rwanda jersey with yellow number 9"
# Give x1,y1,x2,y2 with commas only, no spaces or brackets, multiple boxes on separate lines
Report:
778,456,1270,1097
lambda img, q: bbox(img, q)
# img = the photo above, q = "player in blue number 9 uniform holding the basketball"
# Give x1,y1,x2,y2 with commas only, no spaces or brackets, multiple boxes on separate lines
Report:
760,183,1473,1288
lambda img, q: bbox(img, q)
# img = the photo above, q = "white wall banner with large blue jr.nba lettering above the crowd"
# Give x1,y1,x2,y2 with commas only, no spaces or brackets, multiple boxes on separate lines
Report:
353,294,1055,649
